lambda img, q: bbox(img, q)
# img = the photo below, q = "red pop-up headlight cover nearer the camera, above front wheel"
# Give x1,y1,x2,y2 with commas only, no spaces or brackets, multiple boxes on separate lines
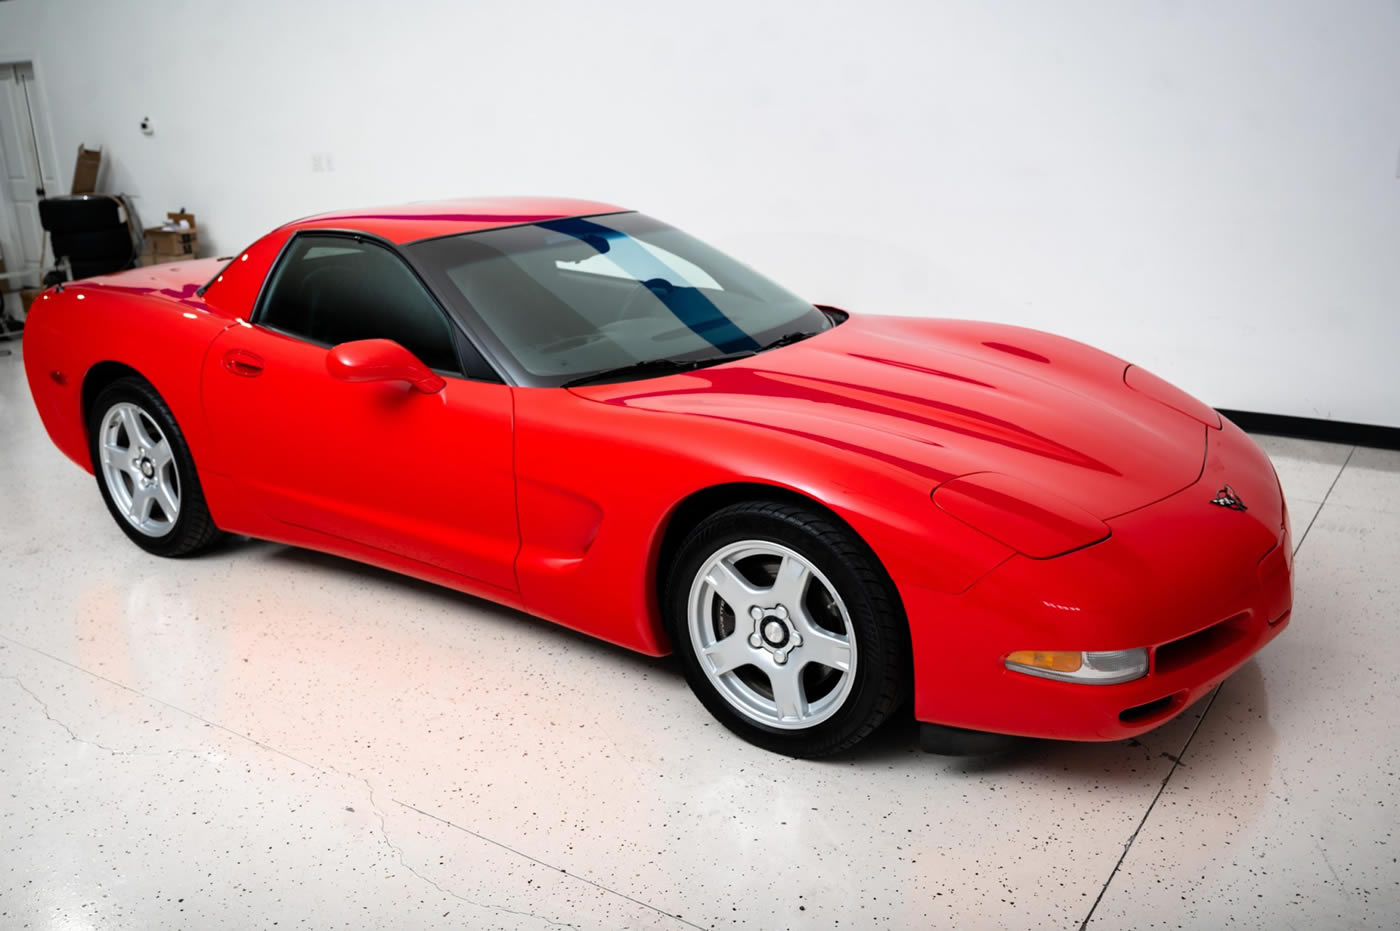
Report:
934,472,1109,559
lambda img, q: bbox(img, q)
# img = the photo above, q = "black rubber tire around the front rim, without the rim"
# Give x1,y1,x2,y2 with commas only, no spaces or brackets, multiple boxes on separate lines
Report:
662,501,913,757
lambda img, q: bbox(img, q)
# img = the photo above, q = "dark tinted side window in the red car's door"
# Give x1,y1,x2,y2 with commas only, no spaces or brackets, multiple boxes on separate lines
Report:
258,235,461,374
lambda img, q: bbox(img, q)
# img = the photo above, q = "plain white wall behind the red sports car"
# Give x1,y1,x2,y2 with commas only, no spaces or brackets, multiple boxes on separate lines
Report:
0,0,1400,426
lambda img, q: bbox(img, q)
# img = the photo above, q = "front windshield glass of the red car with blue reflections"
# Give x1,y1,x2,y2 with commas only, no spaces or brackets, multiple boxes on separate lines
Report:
407,213,832,386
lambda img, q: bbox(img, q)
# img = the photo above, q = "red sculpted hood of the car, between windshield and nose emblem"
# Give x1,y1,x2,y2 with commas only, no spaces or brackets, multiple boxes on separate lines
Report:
573,315,1207,519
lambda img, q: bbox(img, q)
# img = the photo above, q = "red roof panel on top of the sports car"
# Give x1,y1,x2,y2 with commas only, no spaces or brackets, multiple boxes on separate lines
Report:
286,196,626,244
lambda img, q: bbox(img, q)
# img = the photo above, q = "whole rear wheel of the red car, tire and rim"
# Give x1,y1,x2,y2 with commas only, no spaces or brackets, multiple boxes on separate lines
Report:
88,378,221,556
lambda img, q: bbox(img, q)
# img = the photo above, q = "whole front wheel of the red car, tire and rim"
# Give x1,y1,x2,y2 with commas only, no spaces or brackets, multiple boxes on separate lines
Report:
665,501,910,757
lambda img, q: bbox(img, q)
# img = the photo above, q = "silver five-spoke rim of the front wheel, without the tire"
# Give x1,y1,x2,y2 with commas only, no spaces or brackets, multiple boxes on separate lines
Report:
686,540,855,731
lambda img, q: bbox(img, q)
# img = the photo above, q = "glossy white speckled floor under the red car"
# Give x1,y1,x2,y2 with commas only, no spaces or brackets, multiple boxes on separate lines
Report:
0,344,1400,928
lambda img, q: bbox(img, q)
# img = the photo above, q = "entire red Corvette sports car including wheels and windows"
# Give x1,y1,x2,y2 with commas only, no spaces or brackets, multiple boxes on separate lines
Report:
24,197,1292,756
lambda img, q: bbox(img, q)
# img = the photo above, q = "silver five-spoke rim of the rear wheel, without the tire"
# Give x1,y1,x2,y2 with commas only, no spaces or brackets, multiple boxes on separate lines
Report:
98,400,181,536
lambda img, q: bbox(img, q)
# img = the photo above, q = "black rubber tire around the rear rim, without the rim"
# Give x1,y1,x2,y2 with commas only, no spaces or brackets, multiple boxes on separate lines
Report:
87,377,223,557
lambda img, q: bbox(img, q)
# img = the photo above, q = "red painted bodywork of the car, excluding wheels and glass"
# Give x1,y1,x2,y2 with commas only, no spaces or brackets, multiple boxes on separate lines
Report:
24,199,1292,756
